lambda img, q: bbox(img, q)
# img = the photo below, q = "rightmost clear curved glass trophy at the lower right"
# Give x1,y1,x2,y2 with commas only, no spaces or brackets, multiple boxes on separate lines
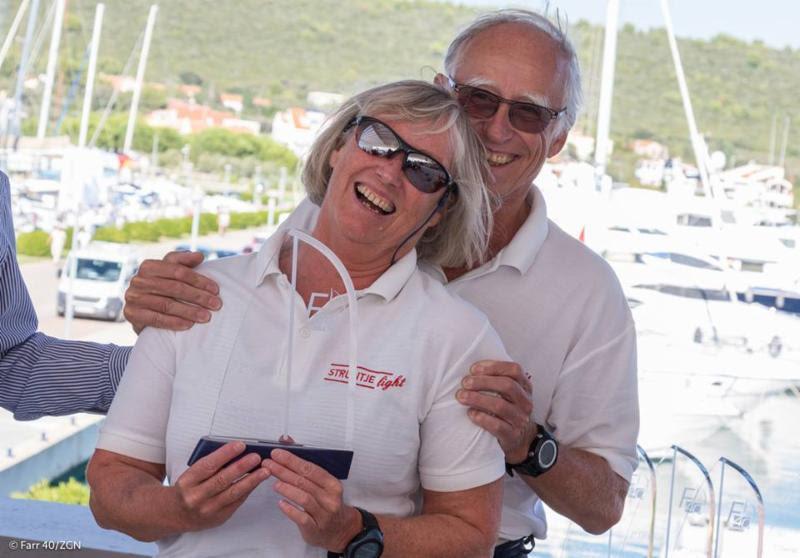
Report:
714,457,764,558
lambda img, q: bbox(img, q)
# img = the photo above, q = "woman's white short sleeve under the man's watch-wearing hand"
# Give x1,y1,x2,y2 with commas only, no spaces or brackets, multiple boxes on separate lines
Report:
419,321,509,492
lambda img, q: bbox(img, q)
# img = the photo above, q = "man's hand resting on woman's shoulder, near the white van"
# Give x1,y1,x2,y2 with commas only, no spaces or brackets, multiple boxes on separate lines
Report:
125,252,222,334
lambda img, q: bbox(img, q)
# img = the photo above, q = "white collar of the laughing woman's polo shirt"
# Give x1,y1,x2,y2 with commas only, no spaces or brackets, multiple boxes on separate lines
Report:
253,223,417,302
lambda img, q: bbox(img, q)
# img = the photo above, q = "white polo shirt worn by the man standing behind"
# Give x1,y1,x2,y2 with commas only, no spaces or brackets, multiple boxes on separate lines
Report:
289,186,639,540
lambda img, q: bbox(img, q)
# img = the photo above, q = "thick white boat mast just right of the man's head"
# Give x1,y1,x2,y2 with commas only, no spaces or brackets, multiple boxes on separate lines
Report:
594,0,619,190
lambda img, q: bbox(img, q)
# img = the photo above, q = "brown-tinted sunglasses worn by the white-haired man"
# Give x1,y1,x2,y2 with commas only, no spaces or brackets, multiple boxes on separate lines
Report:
447,77,567,134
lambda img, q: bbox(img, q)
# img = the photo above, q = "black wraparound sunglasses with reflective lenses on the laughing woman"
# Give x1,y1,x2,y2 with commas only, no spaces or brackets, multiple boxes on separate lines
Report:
345,116,456,194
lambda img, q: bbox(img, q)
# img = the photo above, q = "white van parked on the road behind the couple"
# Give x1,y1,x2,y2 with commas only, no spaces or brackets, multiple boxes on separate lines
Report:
56,242,139,321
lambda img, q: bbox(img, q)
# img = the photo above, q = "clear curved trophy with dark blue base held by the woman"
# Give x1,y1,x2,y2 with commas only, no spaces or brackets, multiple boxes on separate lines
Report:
188,229,358,480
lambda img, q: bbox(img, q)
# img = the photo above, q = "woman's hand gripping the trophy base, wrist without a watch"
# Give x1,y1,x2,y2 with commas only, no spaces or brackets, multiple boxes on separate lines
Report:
172,442,269,531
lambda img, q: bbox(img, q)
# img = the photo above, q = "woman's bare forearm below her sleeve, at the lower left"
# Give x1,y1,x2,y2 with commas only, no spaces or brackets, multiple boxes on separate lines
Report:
86,454,184,541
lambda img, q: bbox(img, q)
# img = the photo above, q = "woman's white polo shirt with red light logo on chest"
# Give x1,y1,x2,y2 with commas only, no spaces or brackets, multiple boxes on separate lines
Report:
98,230,507,557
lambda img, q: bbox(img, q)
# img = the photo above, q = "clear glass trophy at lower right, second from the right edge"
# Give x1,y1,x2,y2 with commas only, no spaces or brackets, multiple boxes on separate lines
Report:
661,446,716,558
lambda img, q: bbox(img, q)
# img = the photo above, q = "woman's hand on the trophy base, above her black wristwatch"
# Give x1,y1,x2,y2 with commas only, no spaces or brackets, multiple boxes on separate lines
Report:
263,449,362,552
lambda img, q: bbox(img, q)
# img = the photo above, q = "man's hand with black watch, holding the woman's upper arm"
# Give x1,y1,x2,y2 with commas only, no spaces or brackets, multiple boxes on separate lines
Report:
456,360,536,463
